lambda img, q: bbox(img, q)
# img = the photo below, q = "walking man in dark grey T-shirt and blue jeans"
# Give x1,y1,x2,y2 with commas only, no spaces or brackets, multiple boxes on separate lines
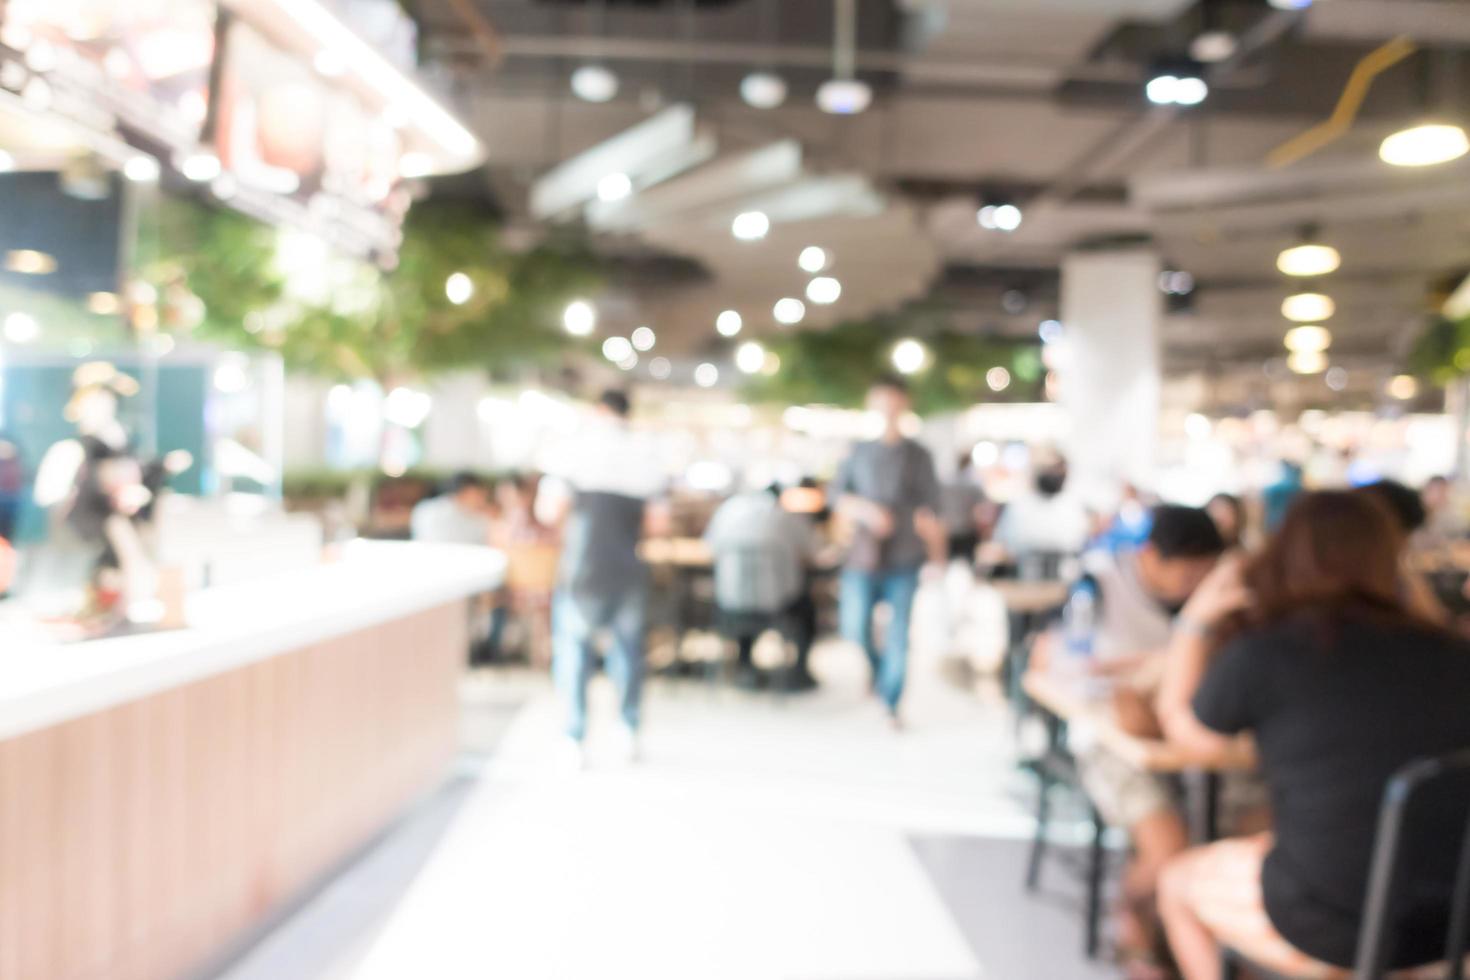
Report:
831,376,945,729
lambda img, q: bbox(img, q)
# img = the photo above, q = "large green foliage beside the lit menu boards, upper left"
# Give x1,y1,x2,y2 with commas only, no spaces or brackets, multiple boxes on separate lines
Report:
144,200,597,386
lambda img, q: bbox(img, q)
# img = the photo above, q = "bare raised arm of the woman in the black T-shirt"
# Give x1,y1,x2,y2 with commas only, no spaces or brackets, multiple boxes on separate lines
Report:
1155,557,1250,763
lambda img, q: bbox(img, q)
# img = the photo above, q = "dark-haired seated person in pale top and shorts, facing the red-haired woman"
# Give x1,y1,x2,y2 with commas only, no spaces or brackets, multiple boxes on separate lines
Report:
1046,504,1225,976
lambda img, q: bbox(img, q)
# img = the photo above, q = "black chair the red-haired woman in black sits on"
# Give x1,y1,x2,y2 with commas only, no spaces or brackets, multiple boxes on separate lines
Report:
1223,749,1470,980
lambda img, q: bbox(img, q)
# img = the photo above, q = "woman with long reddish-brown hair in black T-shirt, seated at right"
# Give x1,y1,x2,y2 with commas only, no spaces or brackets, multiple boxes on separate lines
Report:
1158,492,1470,980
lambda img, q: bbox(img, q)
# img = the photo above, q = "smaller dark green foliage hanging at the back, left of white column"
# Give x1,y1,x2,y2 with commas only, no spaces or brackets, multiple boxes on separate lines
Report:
750,320,1045,414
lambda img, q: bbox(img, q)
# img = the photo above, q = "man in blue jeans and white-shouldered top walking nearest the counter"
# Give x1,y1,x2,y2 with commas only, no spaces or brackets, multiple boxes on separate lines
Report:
547,391,664,768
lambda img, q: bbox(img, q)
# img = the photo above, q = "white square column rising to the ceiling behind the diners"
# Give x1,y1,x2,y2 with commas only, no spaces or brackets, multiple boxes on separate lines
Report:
1057,250,1164,501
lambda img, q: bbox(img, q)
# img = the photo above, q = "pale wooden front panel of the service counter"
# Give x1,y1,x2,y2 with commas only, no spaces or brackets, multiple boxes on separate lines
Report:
0,602,469,980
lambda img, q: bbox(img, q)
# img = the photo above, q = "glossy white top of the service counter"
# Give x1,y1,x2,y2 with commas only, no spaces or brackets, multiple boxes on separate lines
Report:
0,542,506,739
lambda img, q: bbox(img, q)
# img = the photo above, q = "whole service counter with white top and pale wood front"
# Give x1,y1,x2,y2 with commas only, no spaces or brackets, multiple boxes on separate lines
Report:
0,542,504,980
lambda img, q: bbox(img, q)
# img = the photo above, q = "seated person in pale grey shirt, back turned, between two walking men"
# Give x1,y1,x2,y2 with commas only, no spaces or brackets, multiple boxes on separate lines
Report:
704,486,816,689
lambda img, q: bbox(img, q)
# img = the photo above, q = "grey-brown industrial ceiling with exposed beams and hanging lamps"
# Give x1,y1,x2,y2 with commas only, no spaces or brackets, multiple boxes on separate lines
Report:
410,0,1470,402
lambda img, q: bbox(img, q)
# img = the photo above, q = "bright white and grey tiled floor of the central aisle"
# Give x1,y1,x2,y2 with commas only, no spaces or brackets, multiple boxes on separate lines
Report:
214,644,1111,980
